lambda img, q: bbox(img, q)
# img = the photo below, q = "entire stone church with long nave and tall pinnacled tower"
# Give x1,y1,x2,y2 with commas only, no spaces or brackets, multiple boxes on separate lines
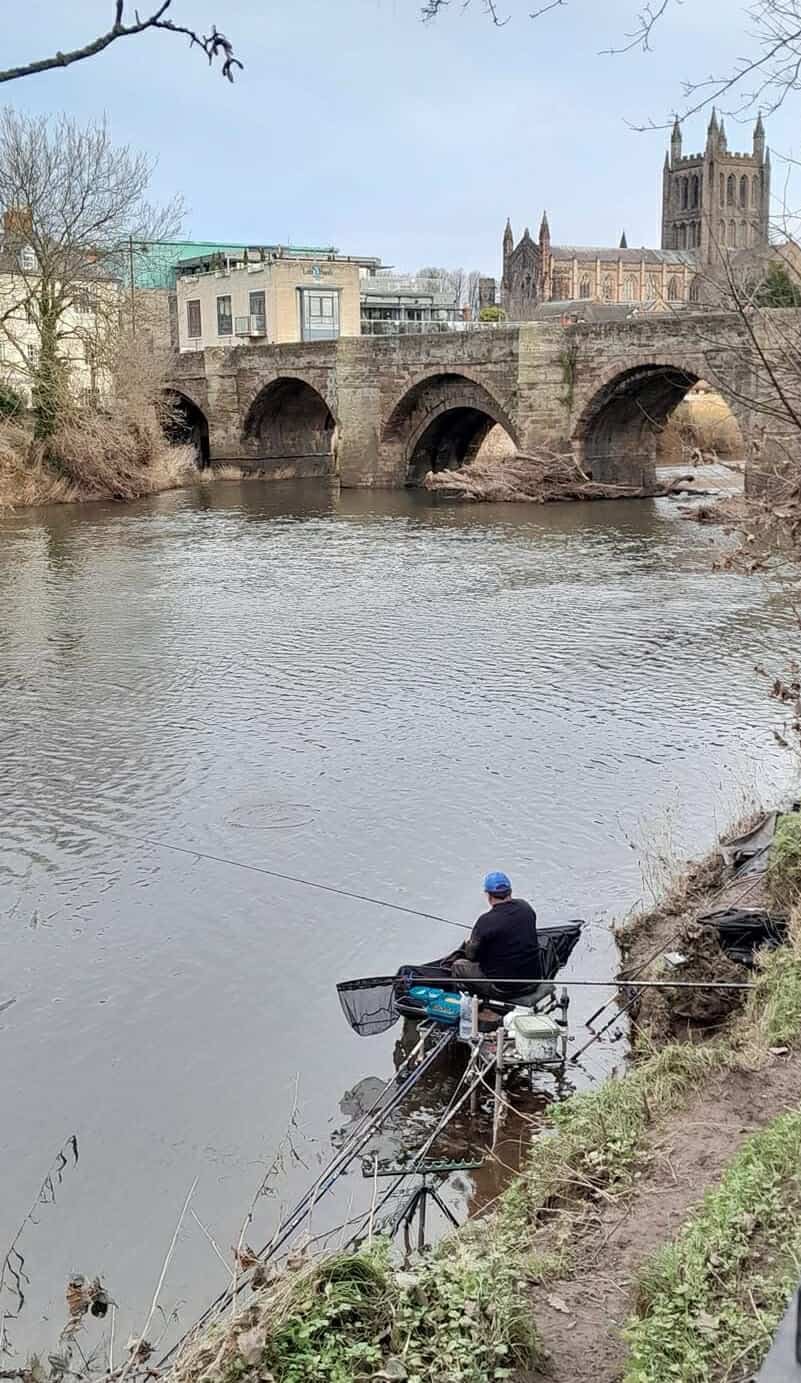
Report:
501,111,771,321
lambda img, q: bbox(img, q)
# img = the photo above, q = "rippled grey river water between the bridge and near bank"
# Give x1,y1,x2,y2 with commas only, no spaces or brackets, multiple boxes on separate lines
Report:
0,481,793,1353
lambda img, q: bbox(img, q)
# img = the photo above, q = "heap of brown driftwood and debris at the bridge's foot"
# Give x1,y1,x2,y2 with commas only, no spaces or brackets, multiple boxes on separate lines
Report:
423,452,704,505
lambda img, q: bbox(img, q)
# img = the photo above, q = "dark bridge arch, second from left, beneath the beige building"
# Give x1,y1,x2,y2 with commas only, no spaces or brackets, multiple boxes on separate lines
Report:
242,375,336,470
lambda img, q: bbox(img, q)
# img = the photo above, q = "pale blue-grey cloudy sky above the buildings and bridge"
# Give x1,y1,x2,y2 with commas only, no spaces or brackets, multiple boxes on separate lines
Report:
3,0,801,272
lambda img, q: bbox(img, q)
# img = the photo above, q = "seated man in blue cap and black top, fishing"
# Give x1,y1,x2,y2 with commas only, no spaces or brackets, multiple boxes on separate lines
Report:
452,870,541,1000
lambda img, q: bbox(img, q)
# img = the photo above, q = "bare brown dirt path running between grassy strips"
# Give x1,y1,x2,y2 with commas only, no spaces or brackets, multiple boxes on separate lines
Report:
526,1052,801,1383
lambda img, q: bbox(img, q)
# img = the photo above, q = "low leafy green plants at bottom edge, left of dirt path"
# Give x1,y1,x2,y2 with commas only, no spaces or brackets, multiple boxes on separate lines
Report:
213,1234,538,1383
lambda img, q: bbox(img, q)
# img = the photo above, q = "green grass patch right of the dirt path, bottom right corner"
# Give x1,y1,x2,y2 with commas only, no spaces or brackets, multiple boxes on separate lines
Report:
624,1111,801,1383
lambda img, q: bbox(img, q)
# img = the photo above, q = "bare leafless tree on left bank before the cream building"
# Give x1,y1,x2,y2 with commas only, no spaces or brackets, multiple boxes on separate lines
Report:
0,108,183,438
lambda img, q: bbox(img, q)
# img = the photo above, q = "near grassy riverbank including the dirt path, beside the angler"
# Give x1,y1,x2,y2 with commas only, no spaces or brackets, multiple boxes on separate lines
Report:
153,822,801,1383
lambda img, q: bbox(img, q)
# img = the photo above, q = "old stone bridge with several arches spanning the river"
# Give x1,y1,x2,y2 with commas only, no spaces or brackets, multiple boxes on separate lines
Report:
170,311,797,487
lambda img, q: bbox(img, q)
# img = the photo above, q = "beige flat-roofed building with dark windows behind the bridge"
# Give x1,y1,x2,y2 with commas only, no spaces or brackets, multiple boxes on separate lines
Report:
176,245,380,351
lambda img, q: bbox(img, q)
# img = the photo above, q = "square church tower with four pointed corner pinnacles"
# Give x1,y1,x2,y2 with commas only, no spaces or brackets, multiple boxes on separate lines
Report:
661,108,771,264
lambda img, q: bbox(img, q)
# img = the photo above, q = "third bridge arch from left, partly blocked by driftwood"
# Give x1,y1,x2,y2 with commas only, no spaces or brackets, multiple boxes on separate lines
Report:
382,372,519,485
